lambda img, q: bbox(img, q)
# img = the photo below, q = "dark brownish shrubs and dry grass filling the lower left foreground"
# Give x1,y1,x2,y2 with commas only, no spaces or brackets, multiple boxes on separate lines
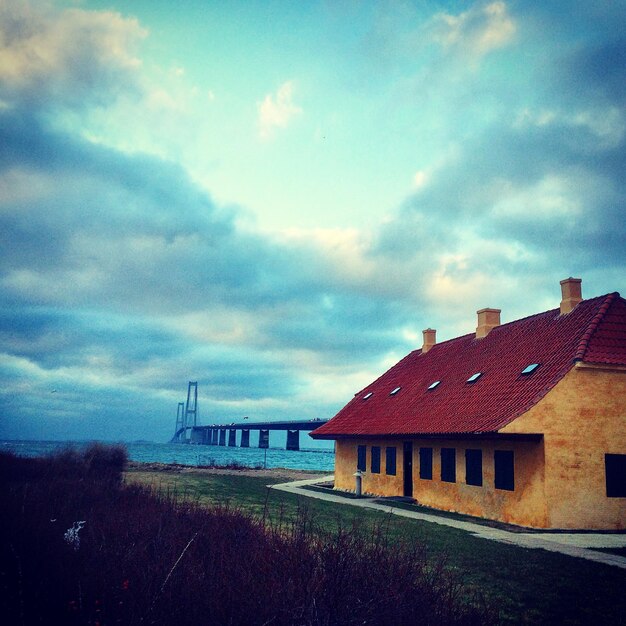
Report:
0,445,497,626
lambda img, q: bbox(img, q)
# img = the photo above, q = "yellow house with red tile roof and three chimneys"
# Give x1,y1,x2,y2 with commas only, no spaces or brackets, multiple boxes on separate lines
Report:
311,278,626,529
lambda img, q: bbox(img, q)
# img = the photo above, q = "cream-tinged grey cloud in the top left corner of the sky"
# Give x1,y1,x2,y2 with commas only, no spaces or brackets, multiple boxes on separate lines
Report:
0,0,146,109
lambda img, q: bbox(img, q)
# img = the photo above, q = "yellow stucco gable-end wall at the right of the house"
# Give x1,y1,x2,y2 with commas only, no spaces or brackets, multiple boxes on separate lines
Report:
501,366,626,529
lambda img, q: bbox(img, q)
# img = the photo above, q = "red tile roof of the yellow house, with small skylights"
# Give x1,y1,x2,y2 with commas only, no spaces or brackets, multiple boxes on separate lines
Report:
311,293,626,439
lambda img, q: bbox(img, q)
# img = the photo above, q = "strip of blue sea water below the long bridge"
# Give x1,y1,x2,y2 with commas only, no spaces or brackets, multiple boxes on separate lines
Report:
0,441,335,472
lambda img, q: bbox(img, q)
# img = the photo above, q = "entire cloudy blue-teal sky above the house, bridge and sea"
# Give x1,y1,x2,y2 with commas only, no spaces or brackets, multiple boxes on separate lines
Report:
0,0,626,445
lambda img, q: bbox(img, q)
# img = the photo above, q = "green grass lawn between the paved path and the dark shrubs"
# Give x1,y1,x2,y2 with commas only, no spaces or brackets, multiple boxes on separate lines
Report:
127,471,626,625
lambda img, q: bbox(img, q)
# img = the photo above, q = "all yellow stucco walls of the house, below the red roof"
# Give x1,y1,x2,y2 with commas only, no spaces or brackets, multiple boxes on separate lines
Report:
335,367,626,529
